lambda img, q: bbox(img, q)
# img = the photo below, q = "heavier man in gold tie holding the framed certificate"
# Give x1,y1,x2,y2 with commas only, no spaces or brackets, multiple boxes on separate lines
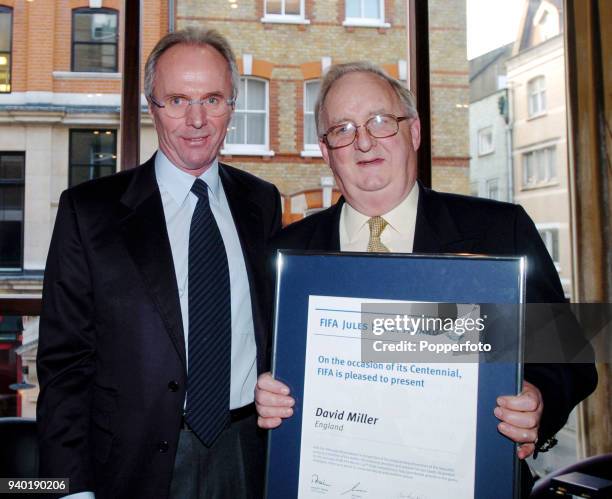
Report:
256,63,597,492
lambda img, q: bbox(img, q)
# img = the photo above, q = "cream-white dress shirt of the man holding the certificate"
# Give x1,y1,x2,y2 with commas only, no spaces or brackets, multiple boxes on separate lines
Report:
340,183,419,253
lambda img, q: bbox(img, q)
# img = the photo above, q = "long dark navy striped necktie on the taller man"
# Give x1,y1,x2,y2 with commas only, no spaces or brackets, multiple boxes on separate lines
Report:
185,179,232,446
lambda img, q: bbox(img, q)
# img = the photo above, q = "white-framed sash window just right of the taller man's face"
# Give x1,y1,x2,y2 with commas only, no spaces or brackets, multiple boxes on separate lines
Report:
225,77,269,154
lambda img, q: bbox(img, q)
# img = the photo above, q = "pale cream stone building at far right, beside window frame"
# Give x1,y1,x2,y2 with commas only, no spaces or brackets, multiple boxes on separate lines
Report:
507,0,572,296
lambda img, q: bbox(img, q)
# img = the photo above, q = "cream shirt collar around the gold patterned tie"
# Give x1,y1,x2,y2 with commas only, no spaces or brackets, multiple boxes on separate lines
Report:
343,182,419,243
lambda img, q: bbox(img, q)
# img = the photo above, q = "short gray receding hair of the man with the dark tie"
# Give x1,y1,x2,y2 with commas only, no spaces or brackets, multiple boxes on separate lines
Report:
145,26,240,99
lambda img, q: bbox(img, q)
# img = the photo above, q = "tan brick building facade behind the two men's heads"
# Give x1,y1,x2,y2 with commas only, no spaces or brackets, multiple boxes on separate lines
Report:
176,0,469,219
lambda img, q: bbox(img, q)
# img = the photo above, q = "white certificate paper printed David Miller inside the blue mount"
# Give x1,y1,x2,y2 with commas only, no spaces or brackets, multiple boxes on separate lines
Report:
298,295,478,499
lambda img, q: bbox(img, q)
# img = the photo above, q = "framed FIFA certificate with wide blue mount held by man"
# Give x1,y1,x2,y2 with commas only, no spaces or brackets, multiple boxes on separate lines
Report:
266,251,525,499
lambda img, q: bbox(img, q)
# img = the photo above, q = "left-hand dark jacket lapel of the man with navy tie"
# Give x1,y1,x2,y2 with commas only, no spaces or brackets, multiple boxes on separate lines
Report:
120,159,186,366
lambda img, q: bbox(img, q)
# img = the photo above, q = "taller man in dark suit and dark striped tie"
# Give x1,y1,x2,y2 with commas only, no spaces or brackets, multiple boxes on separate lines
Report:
38,28,280,499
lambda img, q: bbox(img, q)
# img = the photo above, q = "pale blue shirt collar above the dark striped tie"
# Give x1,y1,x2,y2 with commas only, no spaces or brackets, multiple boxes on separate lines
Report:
155,150,220,206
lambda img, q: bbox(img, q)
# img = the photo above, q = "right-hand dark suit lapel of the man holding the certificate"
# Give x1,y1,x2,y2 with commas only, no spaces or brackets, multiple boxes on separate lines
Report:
412,184,478,253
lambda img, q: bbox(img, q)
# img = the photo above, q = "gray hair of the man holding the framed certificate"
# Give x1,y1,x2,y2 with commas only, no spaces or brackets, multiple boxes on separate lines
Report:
314,61,419,136
